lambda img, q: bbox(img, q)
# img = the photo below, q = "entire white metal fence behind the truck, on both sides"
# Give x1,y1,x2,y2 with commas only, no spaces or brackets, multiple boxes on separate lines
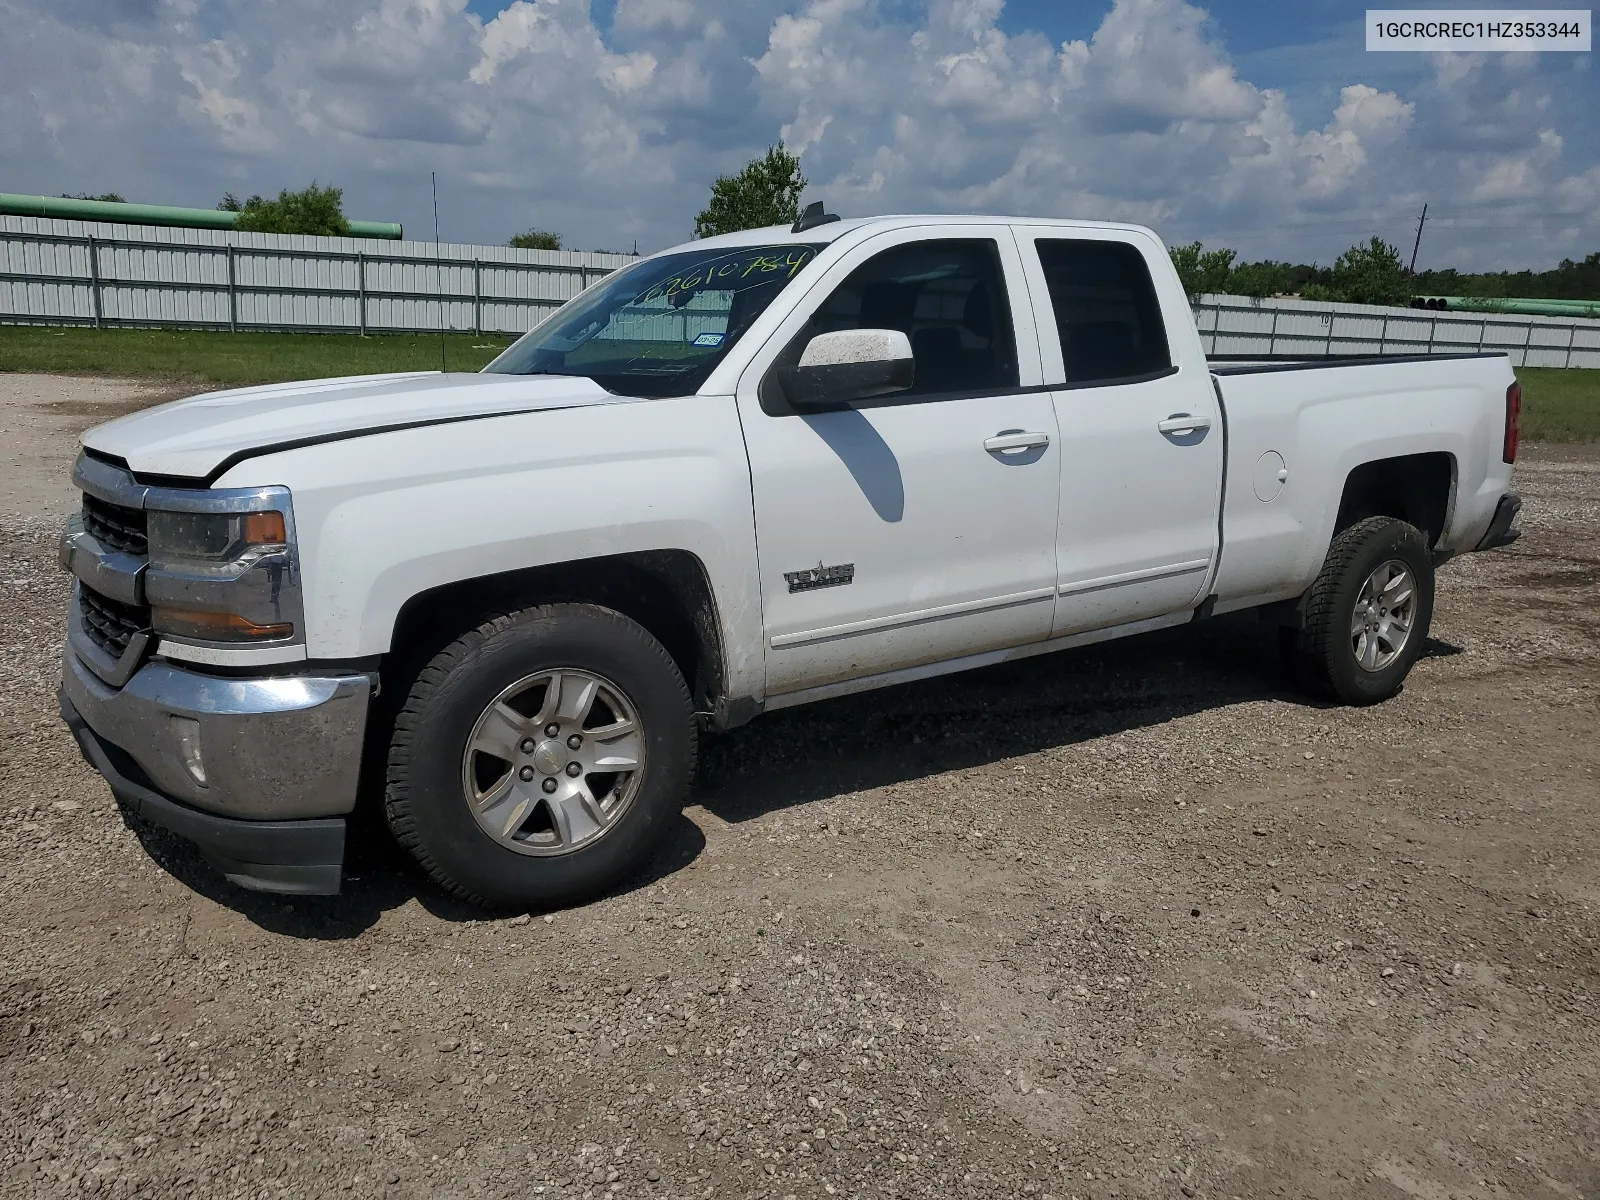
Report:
0,216,1600,368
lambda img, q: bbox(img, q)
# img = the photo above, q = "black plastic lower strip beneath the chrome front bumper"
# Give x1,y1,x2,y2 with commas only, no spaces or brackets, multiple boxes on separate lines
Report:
61,694,344,896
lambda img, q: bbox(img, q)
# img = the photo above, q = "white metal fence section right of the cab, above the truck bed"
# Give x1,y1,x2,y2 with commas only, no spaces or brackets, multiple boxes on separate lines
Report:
1194,296,1600,368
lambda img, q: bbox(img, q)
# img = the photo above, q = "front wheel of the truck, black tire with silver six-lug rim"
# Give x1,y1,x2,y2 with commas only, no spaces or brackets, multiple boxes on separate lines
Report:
384,605,698,910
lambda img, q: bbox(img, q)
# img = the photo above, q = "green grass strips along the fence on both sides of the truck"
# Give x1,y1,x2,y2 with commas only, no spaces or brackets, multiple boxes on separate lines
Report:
0,325,1600,442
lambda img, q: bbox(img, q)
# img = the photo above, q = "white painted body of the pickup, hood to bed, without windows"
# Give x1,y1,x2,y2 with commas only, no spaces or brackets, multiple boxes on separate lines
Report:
85,218,1512,707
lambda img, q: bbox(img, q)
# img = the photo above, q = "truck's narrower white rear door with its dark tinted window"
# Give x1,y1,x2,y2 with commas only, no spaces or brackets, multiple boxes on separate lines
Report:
1018,227,1222,637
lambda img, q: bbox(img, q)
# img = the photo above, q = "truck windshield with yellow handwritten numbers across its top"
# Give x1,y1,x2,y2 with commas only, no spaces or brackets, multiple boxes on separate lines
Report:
483,242,826,397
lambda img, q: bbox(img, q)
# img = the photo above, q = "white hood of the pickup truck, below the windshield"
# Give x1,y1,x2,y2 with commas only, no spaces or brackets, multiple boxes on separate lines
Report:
83,371,627,480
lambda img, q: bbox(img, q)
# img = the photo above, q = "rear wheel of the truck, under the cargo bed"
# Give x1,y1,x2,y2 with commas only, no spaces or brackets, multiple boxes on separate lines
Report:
1278,517,1434,704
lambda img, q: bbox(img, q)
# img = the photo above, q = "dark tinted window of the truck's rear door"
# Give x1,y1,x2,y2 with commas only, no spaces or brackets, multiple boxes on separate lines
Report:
1035,238,1173,384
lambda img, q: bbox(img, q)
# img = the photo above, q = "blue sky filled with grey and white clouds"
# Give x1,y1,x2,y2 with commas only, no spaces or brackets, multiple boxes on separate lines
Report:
0,0,1600,269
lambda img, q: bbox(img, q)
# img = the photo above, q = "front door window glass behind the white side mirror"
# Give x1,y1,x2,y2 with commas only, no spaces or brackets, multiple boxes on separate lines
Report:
779,238,1018,395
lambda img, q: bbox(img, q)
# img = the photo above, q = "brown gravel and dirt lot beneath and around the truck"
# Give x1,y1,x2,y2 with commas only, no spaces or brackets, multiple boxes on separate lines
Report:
0,376,1600,1200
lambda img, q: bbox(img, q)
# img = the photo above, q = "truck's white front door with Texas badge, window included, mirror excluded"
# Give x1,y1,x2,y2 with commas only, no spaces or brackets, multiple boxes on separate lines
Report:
739,224,1061,702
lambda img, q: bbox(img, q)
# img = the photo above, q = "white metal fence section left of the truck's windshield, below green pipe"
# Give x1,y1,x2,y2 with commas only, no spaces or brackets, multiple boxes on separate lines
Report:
0,216,634,333
